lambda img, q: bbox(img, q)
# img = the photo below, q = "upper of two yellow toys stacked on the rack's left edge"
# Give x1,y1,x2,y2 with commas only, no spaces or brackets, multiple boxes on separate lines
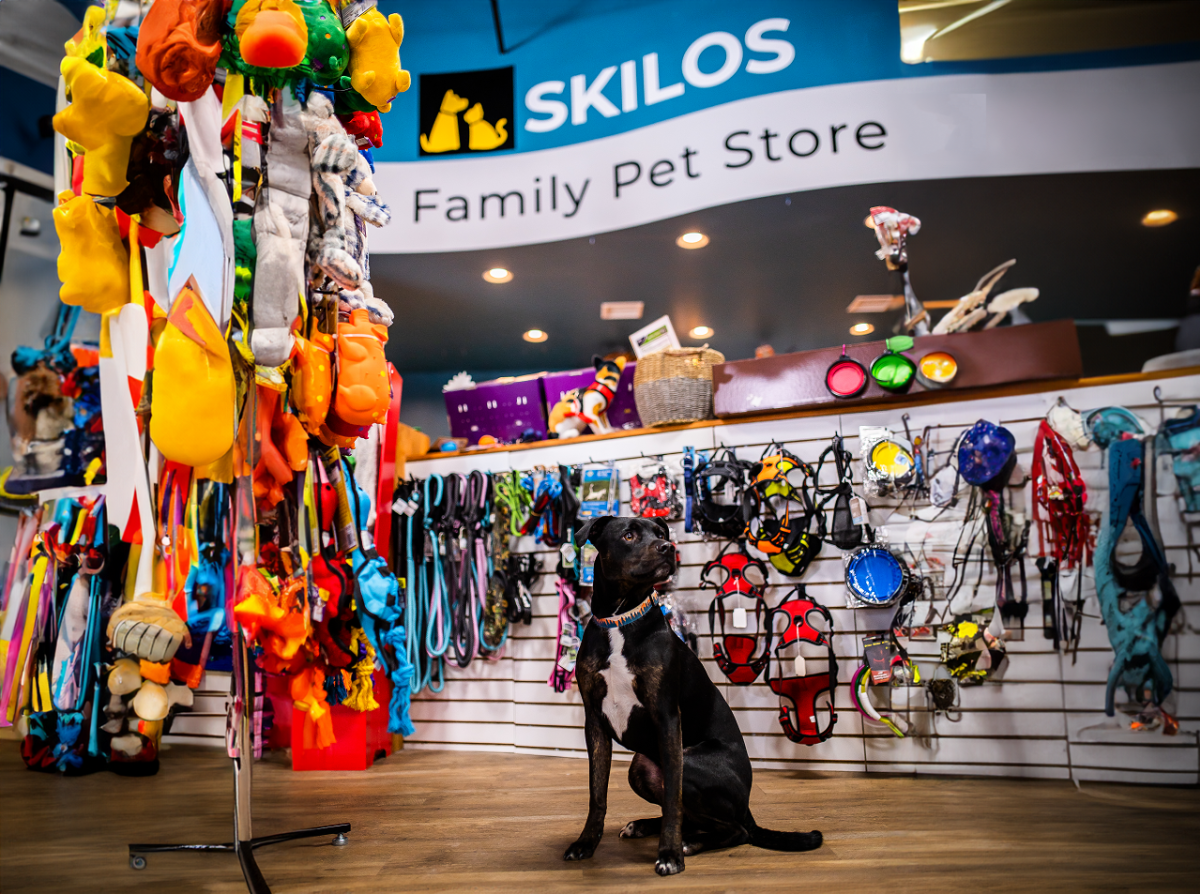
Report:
54,56,150,196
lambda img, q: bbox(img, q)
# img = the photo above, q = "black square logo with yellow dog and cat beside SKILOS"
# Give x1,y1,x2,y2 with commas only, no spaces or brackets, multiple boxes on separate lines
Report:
420,66,516,155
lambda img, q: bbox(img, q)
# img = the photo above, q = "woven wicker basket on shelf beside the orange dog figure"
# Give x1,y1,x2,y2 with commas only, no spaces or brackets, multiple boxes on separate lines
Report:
634,344,725,425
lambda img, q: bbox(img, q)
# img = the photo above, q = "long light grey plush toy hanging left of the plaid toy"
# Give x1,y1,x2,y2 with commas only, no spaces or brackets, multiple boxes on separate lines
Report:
250,98,312,366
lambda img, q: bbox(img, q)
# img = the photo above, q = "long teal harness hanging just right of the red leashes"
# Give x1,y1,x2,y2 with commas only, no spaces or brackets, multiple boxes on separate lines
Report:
1096,438,1180,716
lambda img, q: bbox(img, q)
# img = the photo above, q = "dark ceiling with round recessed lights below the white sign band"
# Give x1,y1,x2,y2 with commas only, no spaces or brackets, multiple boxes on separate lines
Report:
371,169,1200,372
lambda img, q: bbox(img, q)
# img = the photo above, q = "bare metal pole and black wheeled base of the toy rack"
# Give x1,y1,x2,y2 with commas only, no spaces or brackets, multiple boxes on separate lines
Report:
130,625,350,894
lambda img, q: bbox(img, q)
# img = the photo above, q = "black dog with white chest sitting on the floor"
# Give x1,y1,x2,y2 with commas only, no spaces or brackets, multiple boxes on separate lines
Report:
563,516,821,875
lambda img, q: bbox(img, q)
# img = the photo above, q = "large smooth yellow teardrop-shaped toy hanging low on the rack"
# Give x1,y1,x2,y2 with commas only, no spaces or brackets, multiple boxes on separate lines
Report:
150,287,234,466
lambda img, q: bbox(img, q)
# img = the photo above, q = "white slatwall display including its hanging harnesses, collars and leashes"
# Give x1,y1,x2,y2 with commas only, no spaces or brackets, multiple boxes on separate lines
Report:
396,373,1200,782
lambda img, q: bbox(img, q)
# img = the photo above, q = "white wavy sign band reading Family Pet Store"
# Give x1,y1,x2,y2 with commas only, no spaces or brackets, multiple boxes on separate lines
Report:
371,56,1200,252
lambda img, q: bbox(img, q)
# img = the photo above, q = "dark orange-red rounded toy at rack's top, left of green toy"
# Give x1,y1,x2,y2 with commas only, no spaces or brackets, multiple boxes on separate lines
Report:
137,0,224,102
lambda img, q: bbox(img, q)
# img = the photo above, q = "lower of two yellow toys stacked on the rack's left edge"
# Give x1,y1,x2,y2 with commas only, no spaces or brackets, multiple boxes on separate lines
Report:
54,192,130,313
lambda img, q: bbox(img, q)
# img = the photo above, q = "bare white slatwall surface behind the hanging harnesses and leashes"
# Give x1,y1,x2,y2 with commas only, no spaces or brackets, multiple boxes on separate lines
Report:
408,376,1200,784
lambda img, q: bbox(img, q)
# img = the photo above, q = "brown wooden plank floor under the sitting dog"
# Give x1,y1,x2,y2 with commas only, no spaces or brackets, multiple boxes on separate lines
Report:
0,742,1200,894
